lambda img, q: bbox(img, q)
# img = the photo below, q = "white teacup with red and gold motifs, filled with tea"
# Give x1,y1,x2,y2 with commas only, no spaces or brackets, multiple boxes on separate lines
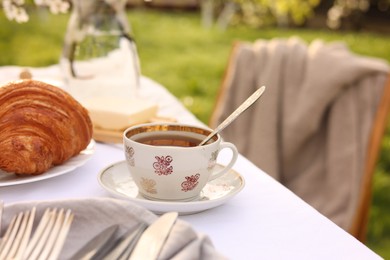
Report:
123,123,238,201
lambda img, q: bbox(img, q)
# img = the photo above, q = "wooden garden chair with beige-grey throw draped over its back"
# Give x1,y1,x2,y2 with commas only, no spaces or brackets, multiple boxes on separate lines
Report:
209,37,390,241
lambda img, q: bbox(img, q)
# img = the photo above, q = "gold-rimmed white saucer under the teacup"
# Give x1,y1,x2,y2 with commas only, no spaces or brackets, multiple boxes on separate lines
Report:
98,161,245,215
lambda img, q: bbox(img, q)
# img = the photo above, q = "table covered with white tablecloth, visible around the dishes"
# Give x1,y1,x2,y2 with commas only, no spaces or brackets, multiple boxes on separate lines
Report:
0,66,381,259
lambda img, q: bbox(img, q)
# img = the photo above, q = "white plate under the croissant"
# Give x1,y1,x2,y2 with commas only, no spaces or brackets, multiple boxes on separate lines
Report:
0,140,95,187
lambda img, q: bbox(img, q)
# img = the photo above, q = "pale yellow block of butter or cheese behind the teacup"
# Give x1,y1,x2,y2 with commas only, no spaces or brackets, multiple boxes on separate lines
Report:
82,97,158,130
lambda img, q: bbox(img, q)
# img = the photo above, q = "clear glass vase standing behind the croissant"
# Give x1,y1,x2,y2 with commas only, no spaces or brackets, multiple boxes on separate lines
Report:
60,0,140,101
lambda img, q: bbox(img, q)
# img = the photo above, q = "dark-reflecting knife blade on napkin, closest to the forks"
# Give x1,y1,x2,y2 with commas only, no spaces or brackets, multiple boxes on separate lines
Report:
70,224,119,260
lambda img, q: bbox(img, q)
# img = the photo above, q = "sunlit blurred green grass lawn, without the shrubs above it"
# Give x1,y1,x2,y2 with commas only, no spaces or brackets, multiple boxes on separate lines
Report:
0,9,390,259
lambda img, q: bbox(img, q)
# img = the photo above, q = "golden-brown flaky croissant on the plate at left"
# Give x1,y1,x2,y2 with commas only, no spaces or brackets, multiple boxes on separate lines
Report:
0,79,92,175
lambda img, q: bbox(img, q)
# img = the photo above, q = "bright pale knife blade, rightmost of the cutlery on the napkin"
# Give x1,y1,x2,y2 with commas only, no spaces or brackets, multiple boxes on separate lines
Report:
130,212,178,260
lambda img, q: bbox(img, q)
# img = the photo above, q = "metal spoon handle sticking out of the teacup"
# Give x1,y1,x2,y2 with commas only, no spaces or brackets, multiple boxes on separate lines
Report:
199,86,265,146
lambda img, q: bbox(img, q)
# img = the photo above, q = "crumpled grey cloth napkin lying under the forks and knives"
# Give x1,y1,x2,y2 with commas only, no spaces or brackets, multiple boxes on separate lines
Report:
1,198,227,260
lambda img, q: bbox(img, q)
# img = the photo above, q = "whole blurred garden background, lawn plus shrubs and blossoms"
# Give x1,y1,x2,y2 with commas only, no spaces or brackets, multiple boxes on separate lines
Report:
0,0,390,259
